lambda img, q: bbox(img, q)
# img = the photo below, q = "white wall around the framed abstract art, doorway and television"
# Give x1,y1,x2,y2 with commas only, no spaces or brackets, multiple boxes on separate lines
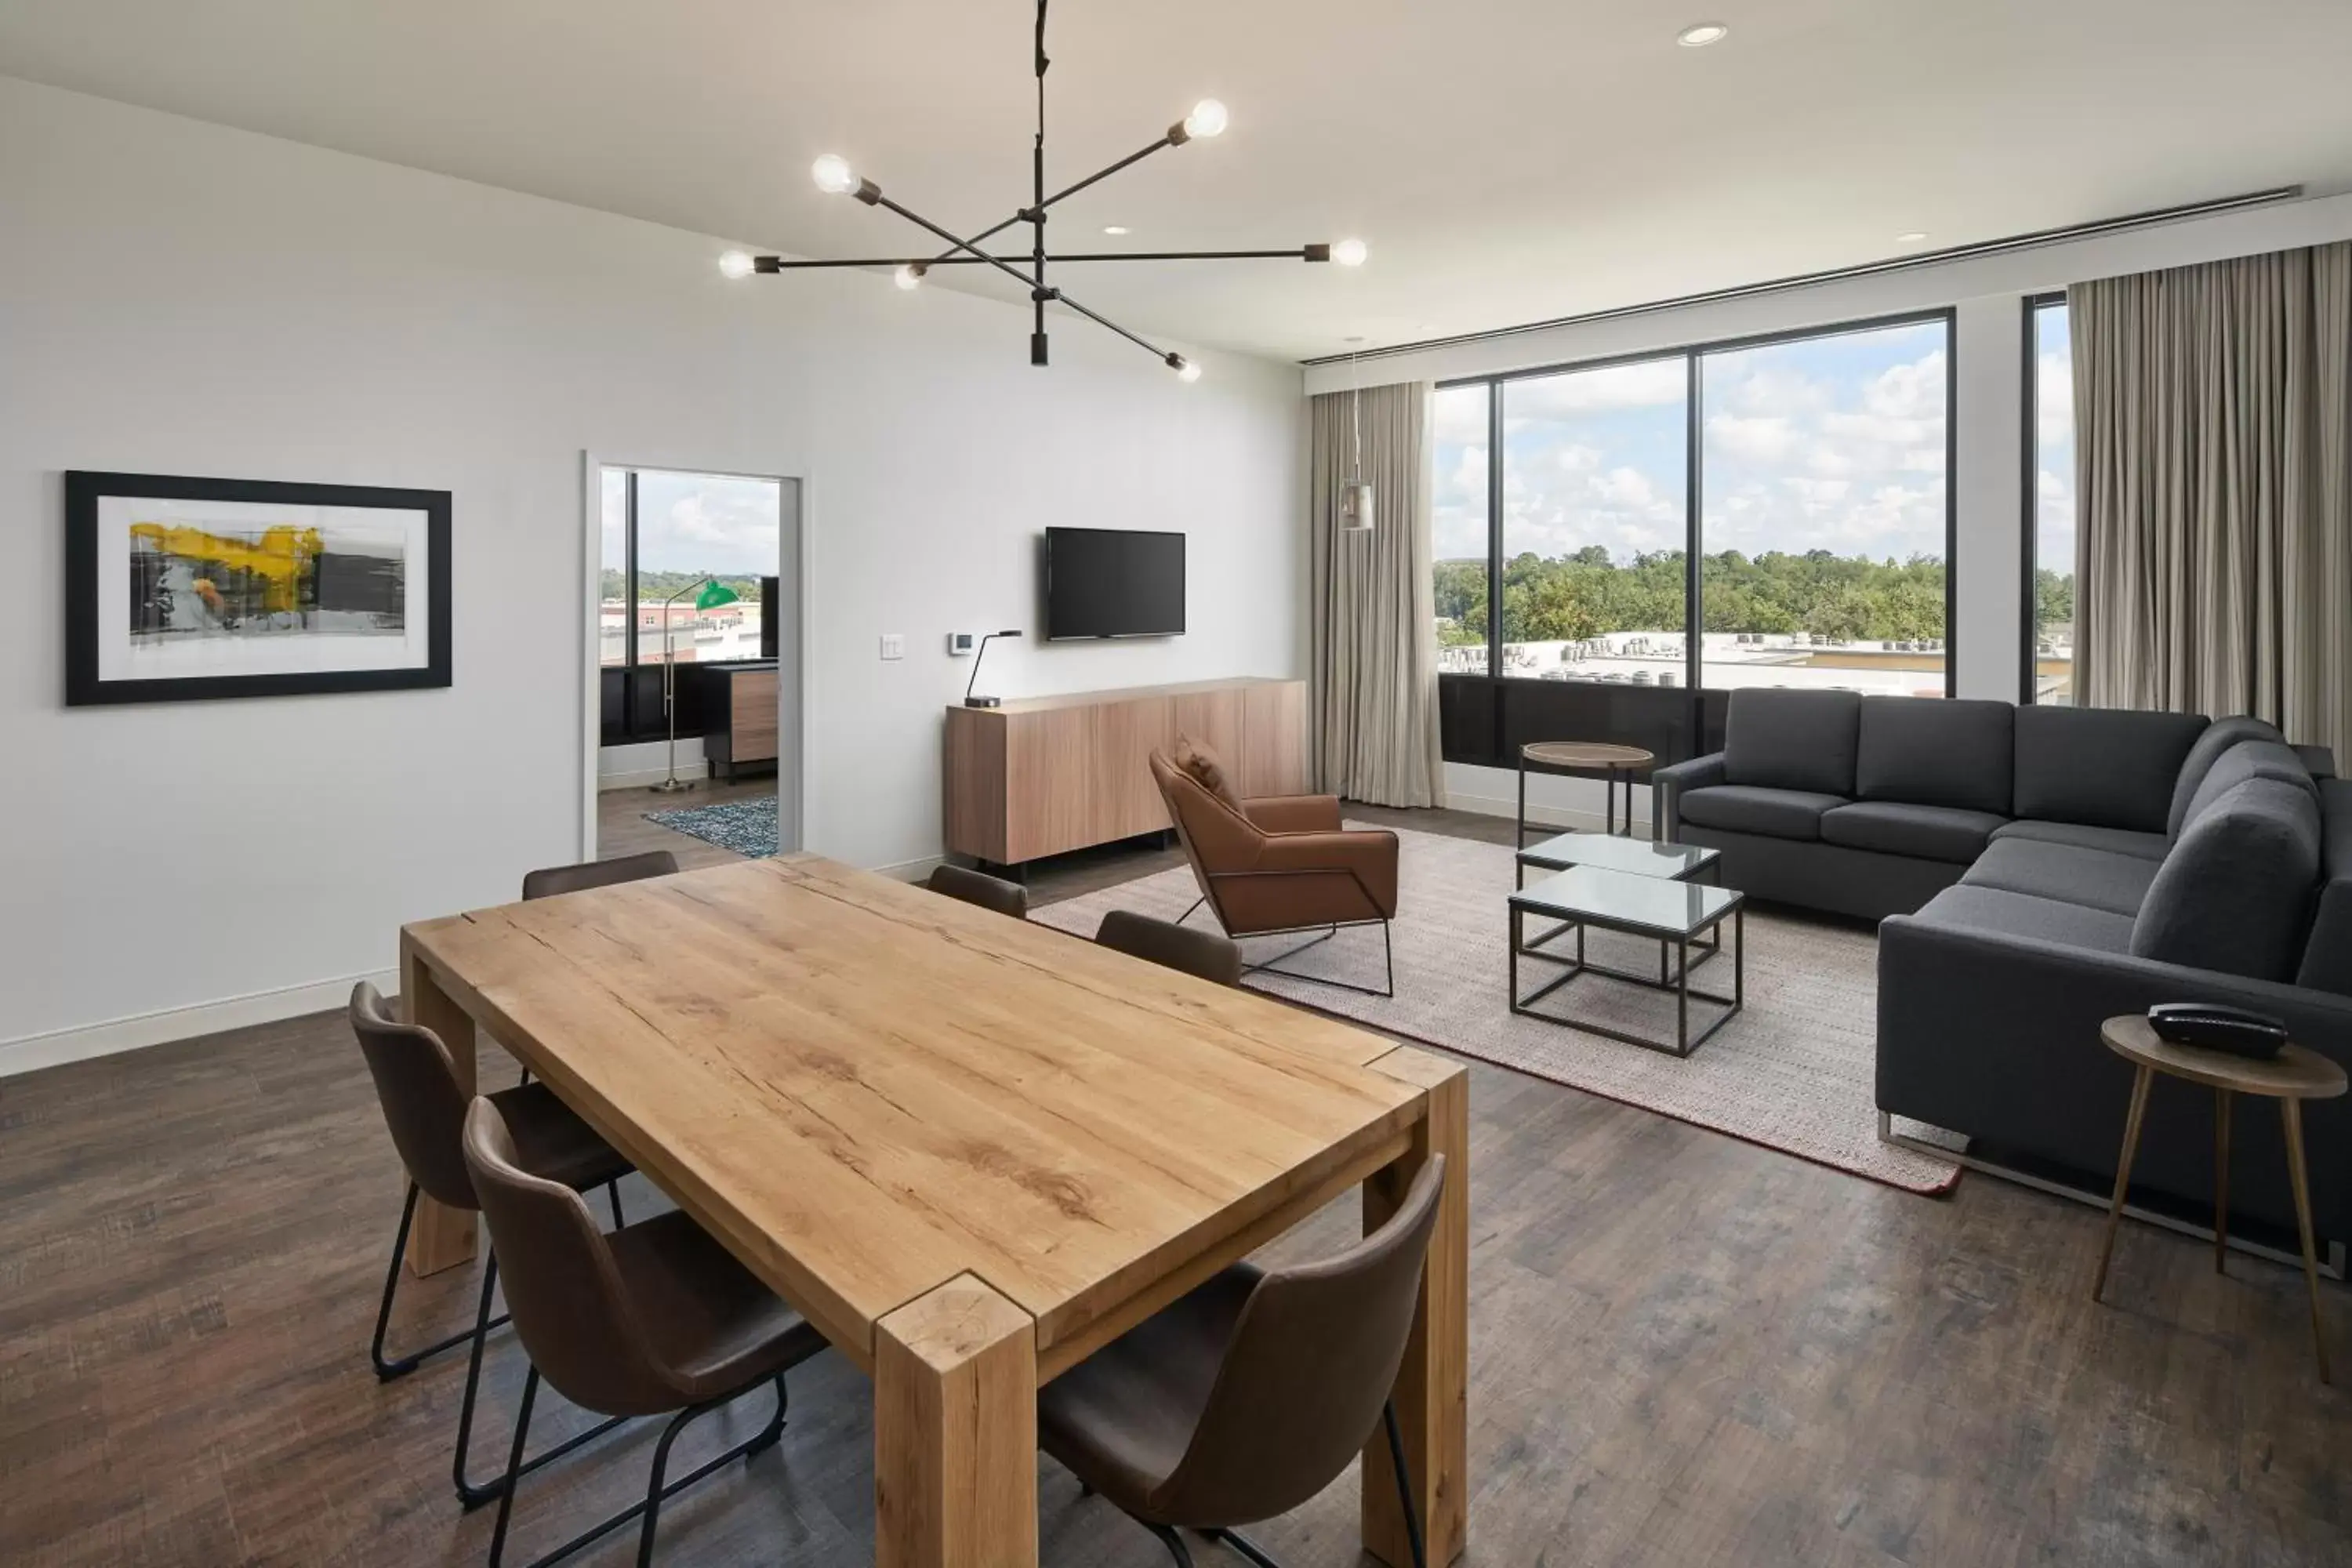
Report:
0,78,1305,1067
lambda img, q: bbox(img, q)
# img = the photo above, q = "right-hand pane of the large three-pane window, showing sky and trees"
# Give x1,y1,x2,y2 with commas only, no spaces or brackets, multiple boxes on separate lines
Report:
1698,320,1950,696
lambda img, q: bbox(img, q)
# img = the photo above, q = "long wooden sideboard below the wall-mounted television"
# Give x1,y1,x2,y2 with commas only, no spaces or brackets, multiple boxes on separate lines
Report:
946,680,1308,865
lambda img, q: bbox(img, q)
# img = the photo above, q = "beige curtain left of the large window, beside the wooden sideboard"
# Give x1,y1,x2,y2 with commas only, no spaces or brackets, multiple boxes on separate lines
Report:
1308,381,1444,806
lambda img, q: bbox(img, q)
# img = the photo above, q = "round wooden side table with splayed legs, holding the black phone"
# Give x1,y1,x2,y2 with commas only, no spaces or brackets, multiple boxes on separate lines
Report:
2091,1015,2345,1382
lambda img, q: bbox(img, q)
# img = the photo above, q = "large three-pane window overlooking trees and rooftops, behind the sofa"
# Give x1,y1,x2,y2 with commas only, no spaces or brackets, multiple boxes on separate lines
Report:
1435,313,1952,696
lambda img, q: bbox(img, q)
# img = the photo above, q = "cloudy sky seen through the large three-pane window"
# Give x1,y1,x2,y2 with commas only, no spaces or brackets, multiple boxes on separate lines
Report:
1432,322,1947,562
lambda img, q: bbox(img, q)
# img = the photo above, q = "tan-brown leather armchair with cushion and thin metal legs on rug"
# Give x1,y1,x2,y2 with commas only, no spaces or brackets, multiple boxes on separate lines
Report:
1152,743,1397,996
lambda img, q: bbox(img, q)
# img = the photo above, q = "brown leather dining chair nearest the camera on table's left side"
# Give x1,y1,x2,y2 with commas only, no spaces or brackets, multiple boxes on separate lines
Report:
463,1098,826,1568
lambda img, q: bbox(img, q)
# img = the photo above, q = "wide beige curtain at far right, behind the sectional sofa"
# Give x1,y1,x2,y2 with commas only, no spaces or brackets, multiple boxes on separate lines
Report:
2067,245,2352,764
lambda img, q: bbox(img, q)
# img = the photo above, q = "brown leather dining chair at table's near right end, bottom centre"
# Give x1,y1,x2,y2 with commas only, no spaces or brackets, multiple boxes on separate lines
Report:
1037,1156,1446,1568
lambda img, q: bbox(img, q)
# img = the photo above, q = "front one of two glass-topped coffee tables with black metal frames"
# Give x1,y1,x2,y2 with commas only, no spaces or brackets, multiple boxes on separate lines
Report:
1510,865,1748,1055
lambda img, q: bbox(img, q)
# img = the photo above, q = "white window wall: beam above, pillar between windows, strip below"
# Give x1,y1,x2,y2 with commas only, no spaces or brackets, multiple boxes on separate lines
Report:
1308,195,2352,827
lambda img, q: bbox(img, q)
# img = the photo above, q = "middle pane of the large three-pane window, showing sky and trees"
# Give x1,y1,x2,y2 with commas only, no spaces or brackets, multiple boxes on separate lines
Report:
1479,355,1691,687
